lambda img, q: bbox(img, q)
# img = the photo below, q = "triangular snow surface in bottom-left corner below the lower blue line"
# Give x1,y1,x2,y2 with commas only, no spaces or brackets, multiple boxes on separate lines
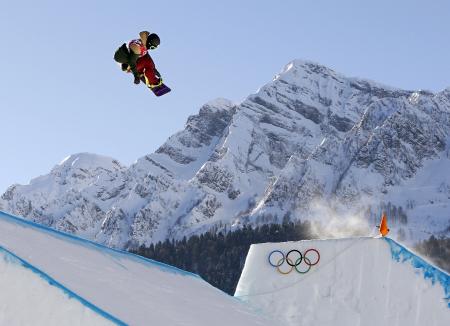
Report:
0,247,116,325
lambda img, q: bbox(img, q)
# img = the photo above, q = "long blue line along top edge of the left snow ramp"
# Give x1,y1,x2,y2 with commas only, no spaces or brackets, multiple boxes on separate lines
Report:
0,211,203,280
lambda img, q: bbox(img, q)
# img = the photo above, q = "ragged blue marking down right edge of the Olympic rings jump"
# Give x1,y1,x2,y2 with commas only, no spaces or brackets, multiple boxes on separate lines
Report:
383,238,450,308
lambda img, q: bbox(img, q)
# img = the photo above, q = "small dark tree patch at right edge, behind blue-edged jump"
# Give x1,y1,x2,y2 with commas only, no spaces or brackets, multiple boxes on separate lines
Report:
415,235,450,273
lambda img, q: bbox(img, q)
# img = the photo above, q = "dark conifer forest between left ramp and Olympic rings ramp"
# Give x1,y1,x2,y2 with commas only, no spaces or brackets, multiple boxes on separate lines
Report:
133,222,313,295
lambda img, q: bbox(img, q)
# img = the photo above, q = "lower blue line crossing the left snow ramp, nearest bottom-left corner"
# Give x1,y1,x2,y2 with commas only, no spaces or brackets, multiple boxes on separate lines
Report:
0,246,128,326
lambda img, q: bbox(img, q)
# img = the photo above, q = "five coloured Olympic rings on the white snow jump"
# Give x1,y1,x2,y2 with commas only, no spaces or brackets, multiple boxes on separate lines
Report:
268,248,320,275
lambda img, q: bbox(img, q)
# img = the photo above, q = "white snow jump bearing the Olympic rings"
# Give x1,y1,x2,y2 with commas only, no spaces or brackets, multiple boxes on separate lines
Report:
235,238,450,326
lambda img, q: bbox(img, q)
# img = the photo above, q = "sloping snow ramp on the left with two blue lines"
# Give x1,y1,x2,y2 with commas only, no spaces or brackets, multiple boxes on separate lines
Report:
0,212,271,326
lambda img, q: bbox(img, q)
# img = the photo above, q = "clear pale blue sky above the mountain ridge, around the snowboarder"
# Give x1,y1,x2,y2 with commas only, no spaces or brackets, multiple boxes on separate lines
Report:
0,0,450,192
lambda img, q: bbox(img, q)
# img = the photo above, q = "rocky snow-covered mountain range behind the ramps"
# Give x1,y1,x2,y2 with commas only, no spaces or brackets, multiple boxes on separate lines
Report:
0,60,450,248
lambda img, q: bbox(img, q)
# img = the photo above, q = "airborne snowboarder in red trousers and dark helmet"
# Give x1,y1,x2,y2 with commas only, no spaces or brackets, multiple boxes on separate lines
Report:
114,31,170,96
